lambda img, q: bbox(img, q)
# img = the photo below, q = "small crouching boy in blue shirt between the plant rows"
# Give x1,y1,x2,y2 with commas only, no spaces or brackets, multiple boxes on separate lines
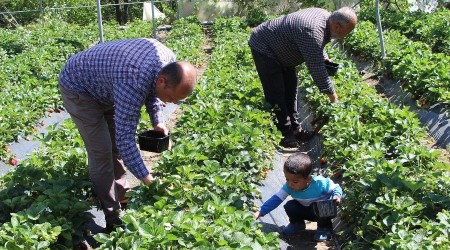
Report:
255,153,342,241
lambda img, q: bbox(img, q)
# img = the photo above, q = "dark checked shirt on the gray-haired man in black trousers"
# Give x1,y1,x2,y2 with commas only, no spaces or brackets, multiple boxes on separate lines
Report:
249,8,334,94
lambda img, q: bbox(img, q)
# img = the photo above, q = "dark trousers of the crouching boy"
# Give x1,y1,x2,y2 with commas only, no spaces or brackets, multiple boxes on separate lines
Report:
284,200,333,229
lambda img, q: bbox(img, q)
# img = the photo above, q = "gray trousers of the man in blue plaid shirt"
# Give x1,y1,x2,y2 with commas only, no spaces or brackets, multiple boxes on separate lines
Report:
60,87,129,223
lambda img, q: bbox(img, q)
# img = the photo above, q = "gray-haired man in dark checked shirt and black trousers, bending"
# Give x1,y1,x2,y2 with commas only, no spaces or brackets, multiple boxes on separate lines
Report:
249,7,357,147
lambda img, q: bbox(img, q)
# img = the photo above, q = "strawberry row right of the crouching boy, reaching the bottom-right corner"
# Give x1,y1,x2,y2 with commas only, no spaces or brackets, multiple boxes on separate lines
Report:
300,45,450,249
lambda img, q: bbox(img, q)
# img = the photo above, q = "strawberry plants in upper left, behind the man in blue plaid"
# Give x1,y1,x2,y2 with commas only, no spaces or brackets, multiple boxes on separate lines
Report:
0,21,95,158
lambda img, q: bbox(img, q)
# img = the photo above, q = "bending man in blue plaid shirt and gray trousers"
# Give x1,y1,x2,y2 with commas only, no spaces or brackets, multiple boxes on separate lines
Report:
59,38,197,231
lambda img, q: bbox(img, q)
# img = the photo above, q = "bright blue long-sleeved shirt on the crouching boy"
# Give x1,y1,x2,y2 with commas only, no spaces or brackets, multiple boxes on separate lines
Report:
260,176,342,216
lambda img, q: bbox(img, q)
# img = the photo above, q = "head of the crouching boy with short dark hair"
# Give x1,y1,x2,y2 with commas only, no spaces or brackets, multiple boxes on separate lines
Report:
284,153,312,191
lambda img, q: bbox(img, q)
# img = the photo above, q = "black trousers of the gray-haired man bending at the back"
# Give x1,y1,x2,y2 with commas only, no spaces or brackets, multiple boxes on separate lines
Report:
252,49,300,135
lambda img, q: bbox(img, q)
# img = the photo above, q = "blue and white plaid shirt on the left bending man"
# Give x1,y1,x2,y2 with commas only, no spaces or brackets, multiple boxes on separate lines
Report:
59,38,175,179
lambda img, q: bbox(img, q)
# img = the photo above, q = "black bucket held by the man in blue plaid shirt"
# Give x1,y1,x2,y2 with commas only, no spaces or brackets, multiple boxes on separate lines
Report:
138,130,170,153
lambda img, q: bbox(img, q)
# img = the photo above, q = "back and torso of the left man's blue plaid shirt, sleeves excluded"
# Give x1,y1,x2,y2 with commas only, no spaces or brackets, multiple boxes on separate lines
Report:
60,38,175,104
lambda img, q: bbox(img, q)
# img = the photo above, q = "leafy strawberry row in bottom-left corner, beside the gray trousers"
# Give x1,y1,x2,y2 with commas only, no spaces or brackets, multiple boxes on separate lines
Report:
0,121,93,249
